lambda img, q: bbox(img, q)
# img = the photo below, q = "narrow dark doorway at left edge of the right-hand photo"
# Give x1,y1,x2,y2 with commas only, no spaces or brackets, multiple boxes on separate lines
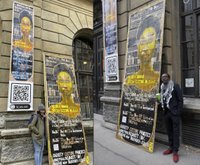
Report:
93,0,104,114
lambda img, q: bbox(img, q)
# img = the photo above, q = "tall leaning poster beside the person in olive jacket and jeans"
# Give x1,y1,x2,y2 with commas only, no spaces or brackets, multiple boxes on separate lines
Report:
44,54,89,165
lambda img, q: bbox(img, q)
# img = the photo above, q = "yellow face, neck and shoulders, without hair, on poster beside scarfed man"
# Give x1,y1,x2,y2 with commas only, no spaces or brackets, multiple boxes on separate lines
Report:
125,18,159,92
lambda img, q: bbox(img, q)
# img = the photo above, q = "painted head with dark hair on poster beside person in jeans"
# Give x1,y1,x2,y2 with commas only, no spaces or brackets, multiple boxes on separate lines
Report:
54,64,74,95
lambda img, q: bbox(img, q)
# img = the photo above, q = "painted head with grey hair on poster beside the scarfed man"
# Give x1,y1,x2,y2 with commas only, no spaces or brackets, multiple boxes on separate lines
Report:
137,16,160,63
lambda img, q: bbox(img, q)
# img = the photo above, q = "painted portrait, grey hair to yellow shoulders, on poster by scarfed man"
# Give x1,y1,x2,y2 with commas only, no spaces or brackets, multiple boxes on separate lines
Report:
125,16,160,92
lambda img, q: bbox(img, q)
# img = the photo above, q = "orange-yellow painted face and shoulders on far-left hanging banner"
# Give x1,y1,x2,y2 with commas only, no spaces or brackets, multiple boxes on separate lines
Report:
13,16,33,52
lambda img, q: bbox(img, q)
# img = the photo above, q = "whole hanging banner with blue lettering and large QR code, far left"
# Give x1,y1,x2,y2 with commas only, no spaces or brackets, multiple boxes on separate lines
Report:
7,2,34,111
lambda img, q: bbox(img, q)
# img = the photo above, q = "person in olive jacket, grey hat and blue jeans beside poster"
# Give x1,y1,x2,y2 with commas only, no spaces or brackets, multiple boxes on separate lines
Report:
28,104,45,165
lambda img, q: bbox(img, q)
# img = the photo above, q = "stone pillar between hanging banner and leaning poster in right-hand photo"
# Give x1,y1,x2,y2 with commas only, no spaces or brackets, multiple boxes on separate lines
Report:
101,0,129,130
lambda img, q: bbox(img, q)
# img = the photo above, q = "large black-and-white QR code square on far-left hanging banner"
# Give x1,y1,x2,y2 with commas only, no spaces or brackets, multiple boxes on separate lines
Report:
11,84,31,103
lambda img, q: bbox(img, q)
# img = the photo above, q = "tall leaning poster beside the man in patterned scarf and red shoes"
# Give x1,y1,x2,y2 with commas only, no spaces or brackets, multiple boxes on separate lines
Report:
117,0,165,152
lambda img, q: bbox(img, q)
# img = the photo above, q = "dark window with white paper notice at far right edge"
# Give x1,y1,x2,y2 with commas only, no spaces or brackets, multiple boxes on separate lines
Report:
181,0,200,97
